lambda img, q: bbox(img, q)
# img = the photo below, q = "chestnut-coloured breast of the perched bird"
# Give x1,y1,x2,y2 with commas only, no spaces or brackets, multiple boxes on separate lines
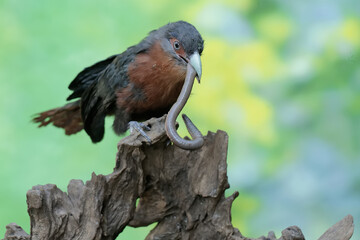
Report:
116,42,186,113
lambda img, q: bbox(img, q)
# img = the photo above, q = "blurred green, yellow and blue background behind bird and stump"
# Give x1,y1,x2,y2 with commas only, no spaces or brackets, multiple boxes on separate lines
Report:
0,0,360,239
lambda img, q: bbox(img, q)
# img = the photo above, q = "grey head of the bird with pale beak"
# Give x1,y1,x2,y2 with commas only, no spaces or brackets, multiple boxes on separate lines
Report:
145,21,204,82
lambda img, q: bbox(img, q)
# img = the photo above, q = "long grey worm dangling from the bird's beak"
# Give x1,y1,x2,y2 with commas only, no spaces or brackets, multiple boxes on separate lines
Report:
165,64,204,150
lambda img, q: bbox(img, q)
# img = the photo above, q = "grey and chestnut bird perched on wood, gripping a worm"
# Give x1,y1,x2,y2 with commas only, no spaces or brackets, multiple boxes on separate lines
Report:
33,21,204,143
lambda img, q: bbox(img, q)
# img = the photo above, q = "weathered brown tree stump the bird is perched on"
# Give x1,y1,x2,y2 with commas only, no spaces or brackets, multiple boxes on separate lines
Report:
4,117,354,240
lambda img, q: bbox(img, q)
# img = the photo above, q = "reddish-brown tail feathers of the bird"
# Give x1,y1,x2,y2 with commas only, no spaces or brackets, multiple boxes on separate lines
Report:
33,101,84,135
